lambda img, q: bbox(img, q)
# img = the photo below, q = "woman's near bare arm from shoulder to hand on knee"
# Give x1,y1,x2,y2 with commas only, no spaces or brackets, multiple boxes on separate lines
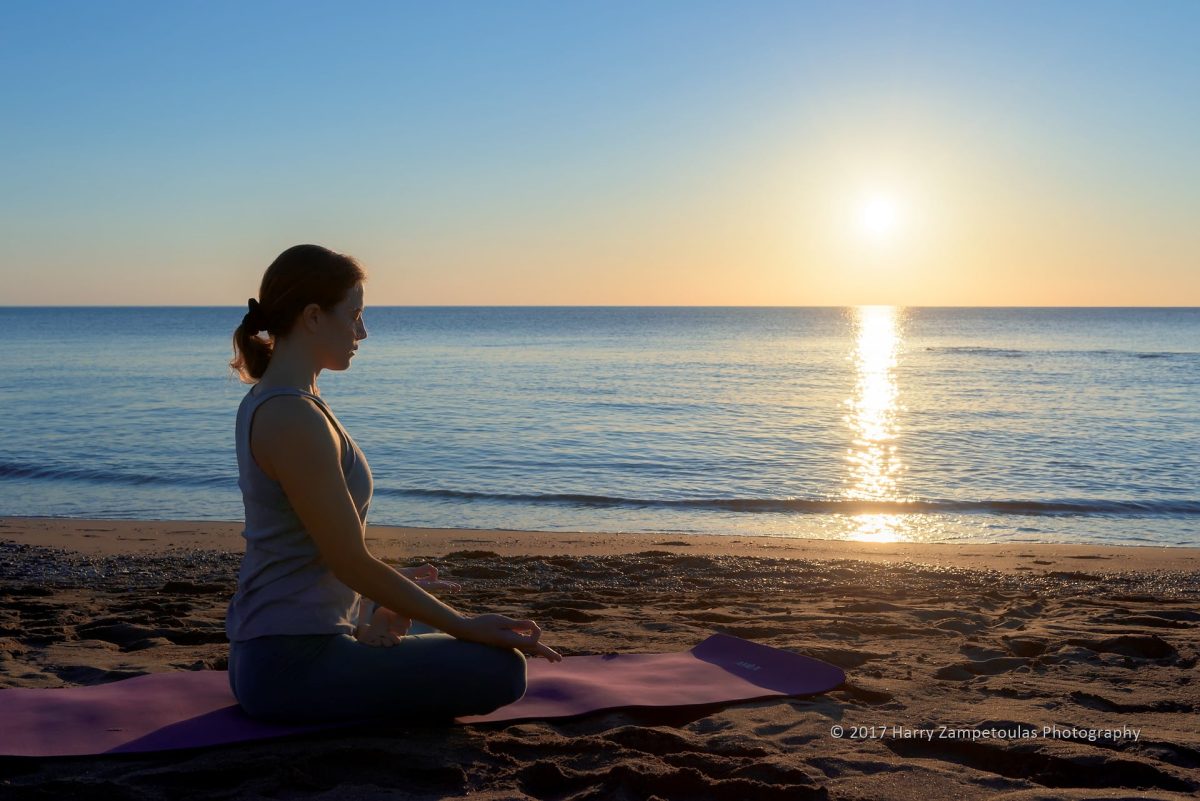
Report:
251,396,562,661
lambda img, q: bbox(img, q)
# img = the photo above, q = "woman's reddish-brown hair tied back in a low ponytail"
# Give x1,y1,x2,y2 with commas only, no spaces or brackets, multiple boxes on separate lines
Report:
229,245,366,384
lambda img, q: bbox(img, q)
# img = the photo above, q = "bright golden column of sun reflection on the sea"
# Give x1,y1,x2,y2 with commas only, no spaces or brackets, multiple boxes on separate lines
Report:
845,306,907,542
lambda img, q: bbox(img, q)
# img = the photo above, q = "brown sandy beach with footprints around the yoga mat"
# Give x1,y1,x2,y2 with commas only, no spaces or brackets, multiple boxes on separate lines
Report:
0,518,1200,801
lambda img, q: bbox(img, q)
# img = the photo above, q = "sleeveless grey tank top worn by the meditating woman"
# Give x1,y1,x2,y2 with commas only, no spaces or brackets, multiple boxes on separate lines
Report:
226,387,373,643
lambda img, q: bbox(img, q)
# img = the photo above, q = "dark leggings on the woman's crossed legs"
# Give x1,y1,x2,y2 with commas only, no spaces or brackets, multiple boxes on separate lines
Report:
229,620,526,722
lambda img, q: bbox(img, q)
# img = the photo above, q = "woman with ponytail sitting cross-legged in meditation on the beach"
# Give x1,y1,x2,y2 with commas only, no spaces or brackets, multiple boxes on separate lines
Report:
226,245,562,721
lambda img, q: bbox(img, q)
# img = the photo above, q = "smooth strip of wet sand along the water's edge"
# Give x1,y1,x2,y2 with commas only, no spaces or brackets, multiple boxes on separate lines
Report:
0,516,1200,574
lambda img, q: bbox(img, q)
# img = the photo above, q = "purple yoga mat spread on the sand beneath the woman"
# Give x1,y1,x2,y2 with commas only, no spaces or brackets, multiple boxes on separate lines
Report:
0,634,846,757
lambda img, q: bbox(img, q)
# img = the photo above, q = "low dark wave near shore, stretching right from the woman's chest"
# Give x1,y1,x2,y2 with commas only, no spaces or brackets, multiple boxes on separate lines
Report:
377,488,1200,517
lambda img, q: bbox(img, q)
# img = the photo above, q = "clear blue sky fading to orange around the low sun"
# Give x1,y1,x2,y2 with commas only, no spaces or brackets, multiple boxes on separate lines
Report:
0,0,1200,306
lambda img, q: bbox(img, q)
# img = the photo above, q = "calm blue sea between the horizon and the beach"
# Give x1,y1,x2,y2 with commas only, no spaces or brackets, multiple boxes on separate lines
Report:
0,307,1200,546
